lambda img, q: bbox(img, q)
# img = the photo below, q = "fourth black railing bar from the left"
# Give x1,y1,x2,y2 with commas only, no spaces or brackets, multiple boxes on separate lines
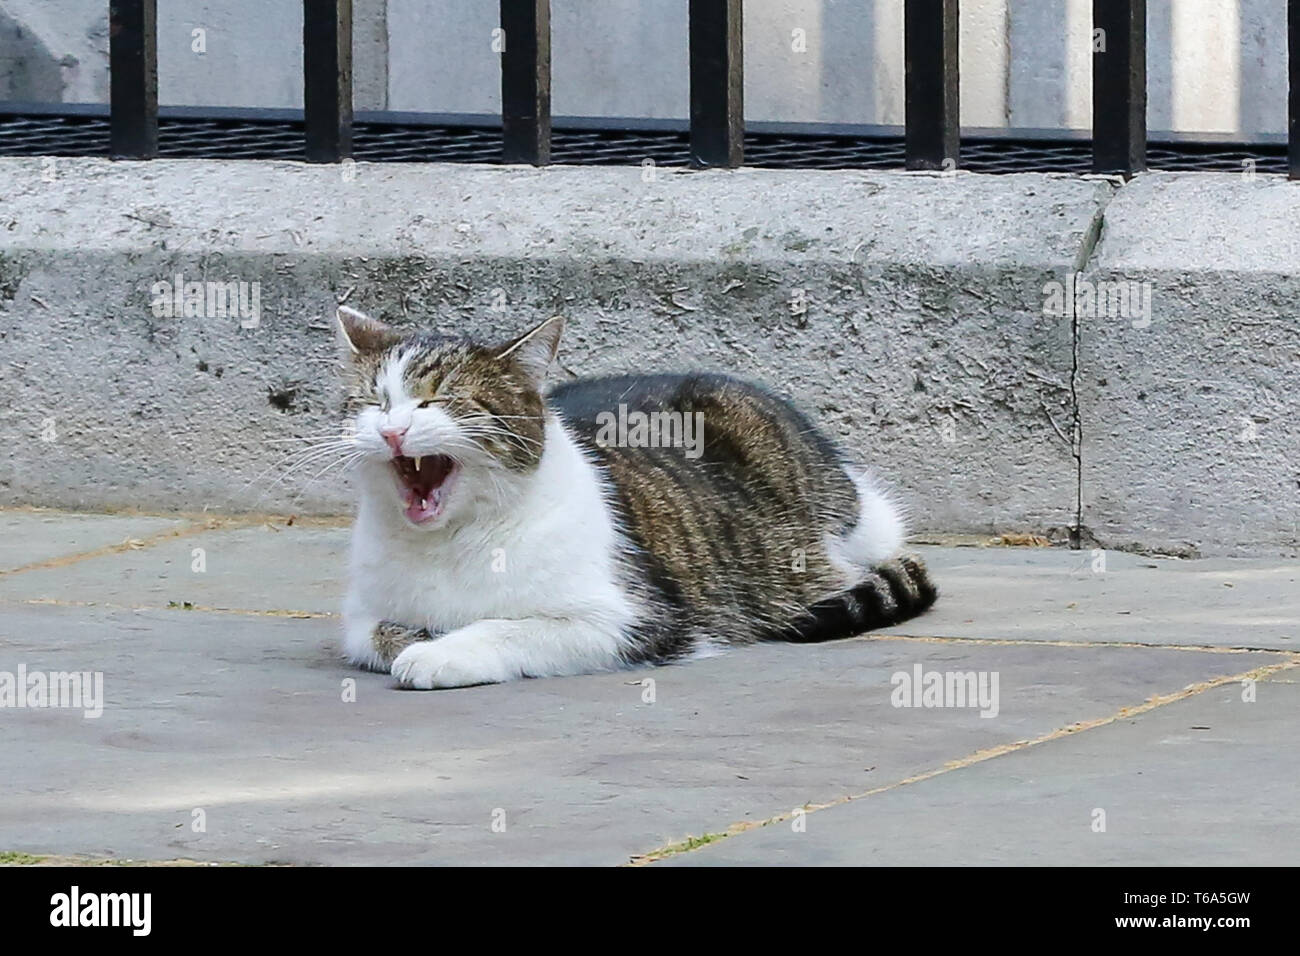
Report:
690,0,745,168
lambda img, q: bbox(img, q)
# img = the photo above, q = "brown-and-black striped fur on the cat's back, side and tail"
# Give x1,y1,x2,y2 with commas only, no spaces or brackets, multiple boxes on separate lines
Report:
549,375,937,661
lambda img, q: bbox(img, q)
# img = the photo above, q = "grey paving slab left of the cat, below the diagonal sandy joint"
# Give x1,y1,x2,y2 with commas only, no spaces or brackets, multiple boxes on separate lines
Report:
0,522,348,613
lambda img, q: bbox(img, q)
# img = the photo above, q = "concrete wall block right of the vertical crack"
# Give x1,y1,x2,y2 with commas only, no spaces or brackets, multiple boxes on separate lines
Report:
1078,173,1300,553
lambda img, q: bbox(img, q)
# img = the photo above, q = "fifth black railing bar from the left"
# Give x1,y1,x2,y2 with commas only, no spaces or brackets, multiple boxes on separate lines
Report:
904,0,961,170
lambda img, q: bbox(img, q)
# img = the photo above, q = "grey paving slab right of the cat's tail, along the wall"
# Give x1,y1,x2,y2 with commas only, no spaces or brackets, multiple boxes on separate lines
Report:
885,548,1300,650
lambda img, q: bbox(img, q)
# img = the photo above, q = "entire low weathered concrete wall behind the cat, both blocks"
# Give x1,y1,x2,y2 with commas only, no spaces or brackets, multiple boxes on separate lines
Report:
0,159,1300,554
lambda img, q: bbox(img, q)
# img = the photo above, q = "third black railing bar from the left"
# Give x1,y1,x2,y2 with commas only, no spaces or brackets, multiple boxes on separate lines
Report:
501,0,551,166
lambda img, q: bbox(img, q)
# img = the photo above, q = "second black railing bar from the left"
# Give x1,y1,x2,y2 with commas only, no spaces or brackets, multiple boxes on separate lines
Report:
303,0,352,163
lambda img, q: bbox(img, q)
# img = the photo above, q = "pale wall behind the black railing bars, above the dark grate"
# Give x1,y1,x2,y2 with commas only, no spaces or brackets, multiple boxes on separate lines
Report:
0,0,1287,139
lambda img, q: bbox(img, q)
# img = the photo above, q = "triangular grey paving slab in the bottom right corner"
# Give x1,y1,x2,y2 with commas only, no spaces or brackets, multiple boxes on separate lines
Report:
662,670,1300,866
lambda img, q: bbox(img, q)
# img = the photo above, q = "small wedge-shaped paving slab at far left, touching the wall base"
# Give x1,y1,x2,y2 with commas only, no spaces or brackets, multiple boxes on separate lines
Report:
0,510,189,574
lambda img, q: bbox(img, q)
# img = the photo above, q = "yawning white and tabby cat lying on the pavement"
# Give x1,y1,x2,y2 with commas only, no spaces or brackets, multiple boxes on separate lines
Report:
330,307,937,689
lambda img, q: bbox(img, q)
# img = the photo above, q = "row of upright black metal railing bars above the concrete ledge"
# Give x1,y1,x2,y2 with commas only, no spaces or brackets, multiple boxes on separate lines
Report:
68,0,1300,178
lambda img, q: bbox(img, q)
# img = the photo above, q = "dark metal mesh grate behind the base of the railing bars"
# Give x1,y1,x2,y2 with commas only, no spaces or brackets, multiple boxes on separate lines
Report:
0,114,1287,173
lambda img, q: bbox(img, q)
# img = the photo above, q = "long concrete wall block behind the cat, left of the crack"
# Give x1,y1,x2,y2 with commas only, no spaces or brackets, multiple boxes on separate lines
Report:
0,159,1112,541
